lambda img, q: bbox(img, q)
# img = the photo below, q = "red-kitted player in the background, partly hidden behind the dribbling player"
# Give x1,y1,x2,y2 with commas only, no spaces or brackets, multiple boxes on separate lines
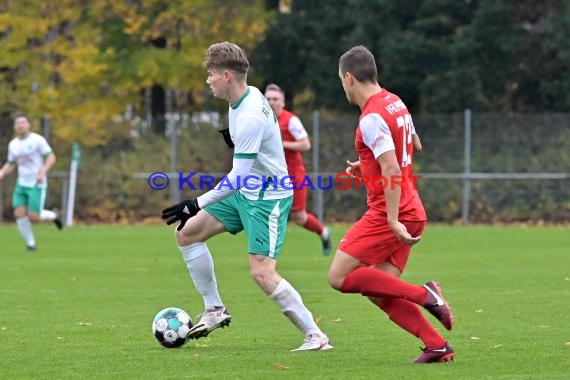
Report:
265,84,332,256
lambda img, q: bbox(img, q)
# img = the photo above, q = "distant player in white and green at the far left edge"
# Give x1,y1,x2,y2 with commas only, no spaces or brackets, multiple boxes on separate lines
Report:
0,113,63,251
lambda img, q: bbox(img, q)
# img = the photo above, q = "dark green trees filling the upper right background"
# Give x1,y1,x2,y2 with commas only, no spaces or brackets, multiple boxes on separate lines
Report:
255,0,570,113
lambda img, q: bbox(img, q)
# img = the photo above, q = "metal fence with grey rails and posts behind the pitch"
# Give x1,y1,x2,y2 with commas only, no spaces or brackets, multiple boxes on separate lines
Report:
0,110,570,224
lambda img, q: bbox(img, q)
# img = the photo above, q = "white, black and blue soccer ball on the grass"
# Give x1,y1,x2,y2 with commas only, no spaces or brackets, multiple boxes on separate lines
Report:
152,307,193,348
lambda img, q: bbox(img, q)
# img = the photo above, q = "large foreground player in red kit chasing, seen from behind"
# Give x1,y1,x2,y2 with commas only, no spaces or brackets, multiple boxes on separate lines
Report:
328,46,455,363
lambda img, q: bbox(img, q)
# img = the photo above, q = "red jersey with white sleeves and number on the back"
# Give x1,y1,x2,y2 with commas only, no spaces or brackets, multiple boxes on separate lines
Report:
355,89,427,221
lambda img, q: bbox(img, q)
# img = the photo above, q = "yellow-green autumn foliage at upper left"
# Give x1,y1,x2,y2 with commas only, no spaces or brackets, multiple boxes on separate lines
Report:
0,0,270,145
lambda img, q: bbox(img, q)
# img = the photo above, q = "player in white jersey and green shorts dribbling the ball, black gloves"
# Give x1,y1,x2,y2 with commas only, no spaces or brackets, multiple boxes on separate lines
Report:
162,42,333,351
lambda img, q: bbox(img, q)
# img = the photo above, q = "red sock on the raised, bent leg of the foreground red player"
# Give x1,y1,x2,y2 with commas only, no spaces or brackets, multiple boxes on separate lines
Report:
340,267,427,306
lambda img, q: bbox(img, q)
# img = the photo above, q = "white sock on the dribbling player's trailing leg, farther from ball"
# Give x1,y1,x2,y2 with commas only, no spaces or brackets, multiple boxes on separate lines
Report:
269,279,324,336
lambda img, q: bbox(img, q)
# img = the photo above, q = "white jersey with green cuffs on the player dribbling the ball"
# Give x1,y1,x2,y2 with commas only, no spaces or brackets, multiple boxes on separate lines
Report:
228,86,293,200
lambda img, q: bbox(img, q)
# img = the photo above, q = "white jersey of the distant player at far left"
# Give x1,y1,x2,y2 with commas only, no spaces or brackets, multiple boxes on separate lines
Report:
8,132,52,187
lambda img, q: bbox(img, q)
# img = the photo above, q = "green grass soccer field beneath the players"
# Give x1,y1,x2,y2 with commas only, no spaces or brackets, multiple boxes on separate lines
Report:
0,225,570,380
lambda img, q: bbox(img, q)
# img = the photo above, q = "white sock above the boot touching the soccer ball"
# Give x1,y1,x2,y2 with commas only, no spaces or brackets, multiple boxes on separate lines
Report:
178,243,224,310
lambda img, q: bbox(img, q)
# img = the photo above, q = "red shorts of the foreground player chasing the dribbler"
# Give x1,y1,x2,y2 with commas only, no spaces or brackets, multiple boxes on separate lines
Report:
338,210,426,272
